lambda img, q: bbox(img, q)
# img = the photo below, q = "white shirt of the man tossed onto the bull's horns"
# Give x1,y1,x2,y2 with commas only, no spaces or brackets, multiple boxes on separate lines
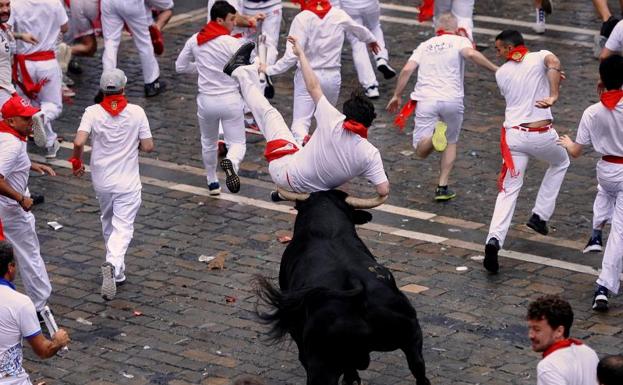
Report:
287,96,387,192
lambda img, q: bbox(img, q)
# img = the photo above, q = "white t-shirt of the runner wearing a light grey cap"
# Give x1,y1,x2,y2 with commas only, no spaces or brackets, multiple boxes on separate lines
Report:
78,104,151,193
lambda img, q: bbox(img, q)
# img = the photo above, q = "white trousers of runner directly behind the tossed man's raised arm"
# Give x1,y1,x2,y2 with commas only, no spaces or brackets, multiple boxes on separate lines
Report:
292,69,342,144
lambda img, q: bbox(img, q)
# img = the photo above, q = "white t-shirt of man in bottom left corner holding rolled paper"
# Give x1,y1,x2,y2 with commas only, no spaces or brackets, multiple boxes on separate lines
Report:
0,280,41,384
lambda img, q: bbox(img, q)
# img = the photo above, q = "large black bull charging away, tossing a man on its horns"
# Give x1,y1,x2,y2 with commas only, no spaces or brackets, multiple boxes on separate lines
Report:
258,190,430,385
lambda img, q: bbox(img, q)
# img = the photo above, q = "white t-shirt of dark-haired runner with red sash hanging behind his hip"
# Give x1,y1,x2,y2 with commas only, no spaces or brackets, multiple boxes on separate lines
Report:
495,50,554,128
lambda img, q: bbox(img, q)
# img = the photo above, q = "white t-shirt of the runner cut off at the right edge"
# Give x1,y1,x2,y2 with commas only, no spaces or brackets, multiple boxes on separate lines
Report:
575,102,623,156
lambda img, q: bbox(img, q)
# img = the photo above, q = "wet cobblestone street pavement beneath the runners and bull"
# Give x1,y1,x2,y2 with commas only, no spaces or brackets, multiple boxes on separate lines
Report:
17,0,623,385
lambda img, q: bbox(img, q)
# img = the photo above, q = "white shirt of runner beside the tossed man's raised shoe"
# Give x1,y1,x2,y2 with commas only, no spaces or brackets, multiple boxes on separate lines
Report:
175,34,242,95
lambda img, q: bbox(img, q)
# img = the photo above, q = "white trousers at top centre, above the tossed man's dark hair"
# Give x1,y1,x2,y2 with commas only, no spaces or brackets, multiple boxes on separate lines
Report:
343,2,389,88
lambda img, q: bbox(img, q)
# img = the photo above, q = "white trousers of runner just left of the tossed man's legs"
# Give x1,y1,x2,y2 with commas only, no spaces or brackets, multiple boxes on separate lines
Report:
197,93,247,184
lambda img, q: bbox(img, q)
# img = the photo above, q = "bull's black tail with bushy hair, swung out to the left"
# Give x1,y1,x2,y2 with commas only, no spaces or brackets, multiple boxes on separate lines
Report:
254,275,364,342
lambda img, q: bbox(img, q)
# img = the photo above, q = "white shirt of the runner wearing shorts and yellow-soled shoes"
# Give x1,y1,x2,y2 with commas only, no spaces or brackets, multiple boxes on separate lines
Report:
409,35,472,102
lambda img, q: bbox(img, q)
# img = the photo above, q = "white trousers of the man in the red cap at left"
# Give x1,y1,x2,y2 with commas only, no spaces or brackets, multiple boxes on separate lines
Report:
0,204,52,311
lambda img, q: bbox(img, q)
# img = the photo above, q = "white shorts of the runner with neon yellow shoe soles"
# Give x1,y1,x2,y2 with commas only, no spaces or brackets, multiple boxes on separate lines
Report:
413,100,464,147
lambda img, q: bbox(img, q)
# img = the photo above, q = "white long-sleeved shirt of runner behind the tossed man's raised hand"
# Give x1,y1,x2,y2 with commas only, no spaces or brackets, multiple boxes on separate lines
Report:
266,7,376,76
